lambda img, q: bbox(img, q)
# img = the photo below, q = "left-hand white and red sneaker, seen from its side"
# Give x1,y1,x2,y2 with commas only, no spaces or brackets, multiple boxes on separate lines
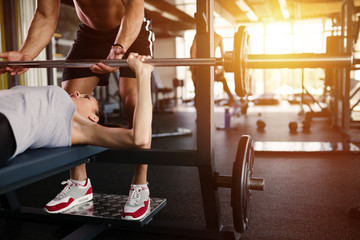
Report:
44,178,93,213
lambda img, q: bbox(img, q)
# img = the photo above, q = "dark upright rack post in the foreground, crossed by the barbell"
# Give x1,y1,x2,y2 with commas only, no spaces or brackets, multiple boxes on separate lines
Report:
195,0,221,231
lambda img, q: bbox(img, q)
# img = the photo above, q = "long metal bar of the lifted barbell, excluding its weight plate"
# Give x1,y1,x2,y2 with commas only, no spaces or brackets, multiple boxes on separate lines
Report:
0,52,354,69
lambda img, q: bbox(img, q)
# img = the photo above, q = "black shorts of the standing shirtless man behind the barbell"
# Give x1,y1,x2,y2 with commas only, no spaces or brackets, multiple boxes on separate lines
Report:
62,16,154,86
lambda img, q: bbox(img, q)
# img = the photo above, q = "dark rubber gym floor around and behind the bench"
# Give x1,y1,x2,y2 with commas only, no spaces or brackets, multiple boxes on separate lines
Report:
0,102,360,240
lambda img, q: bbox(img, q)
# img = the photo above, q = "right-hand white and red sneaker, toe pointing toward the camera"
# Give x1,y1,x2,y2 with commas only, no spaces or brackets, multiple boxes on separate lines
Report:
122,184,150,220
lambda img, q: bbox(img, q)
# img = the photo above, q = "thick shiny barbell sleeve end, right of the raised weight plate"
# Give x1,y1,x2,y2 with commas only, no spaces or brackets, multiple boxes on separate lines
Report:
246,53,353,69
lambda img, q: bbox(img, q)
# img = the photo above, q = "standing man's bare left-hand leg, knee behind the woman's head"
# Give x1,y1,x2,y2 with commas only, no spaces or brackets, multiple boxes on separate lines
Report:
62,77,99,181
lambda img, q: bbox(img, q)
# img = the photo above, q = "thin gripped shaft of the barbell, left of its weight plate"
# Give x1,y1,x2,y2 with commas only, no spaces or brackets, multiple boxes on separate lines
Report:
0,58,224,68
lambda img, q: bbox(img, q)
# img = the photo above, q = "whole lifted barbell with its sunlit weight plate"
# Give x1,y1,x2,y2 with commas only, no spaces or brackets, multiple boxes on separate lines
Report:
0,26,360,97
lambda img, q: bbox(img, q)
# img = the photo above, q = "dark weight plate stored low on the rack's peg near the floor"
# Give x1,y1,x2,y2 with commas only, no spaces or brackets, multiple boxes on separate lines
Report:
231,135,254,233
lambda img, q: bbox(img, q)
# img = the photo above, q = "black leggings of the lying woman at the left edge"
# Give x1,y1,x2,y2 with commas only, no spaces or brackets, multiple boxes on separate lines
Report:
0,113,16,167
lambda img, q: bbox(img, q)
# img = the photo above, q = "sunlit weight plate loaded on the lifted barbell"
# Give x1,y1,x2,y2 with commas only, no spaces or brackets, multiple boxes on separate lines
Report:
233,26,250,97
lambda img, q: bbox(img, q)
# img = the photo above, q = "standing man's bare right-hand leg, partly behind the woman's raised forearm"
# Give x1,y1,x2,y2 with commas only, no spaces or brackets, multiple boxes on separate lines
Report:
119,77,151,184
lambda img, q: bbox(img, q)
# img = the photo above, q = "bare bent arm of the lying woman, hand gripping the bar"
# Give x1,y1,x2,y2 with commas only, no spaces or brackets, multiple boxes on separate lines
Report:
80,53,153,148
